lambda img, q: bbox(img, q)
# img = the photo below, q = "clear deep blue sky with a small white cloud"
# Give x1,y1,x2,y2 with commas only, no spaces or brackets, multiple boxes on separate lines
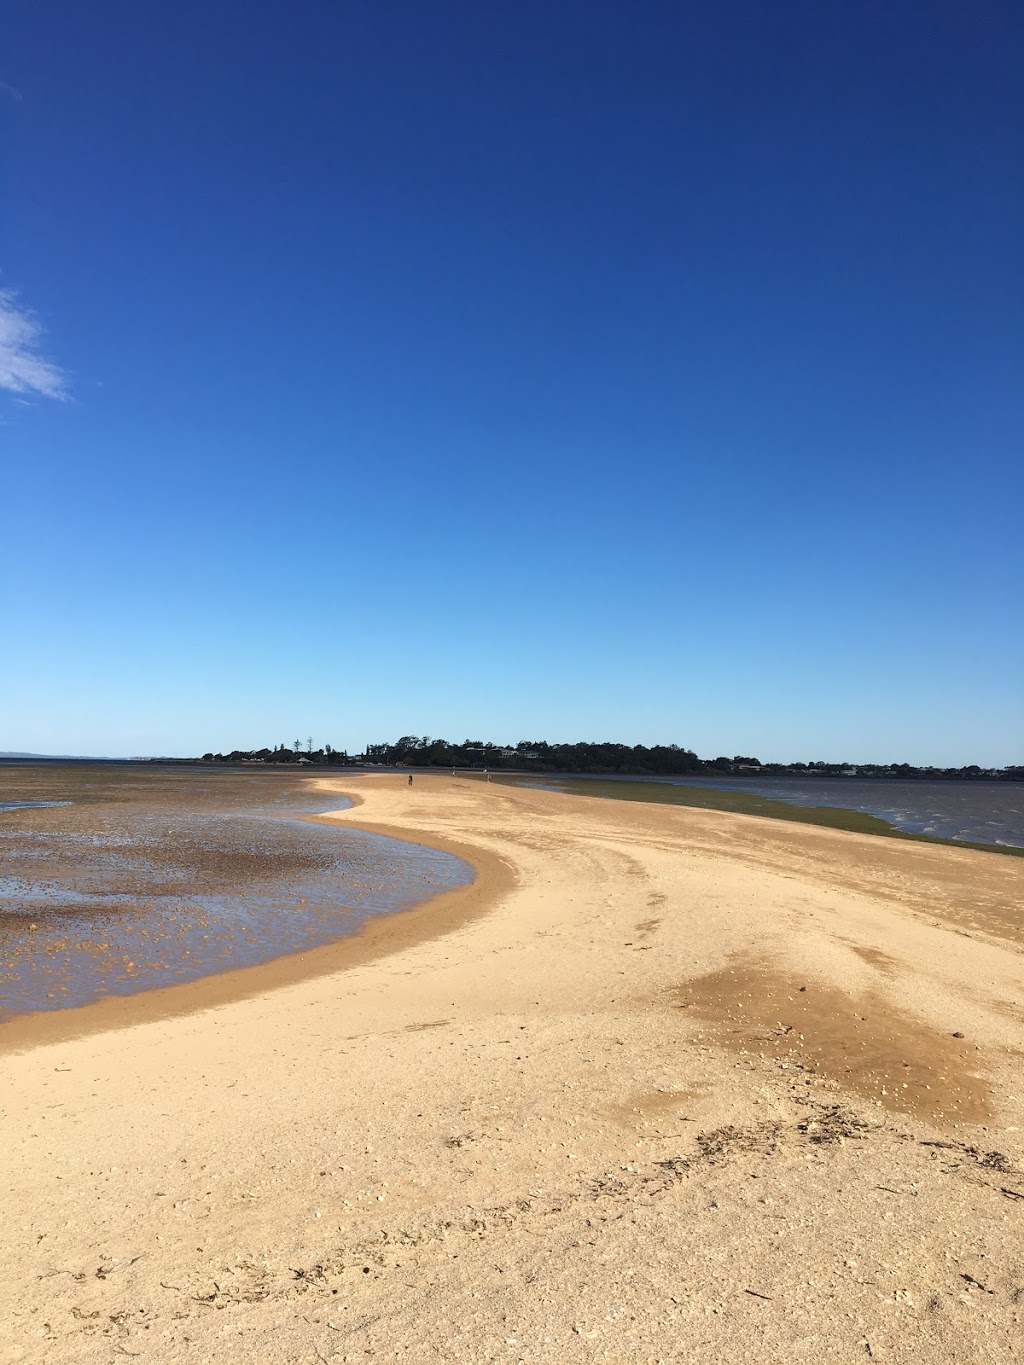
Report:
0,0,1024,763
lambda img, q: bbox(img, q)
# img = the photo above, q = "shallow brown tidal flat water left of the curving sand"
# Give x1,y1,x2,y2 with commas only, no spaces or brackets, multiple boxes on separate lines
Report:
0,768,472,1013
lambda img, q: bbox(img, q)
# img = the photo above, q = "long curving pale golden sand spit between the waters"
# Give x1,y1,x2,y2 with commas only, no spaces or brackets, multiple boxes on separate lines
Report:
0,775,1024,1365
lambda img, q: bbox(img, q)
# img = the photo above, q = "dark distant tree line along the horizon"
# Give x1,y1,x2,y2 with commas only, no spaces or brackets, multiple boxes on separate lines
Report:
196,734,1024,782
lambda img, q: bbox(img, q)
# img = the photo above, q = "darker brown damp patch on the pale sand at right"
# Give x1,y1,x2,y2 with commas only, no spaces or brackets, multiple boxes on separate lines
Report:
673,957,991,1123
